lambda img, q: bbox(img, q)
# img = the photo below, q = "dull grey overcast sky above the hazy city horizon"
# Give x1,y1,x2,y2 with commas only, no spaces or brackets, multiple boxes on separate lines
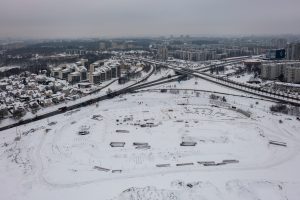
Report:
0,0,300,38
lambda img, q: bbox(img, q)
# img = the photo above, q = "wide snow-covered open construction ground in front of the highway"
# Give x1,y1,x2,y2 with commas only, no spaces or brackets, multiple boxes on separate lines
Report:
0,79,300,200
